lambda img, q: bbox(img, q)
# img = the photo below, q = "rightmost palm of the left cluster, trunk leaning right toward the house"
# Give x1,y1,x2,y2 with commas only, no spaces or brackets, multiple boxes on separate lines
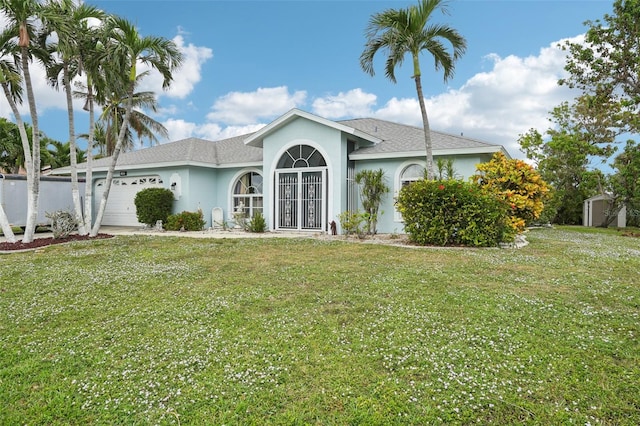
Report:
90,16,182,236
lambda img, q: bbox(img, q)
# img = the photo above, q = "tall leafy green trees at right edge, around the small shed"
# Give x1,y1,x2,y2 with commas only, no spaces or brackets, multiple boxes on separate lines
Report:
519,0,640,227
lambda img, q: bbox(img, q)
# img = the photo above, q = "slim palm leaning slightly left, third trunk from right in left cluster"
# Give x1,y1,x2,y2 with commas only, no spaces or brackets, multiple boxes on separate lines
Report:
42,0,104,235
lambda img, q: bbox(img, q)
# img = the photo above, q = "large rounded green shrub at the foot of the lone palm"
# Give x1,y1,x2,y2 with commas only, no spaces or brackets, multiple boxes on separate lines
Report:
397,180,515,247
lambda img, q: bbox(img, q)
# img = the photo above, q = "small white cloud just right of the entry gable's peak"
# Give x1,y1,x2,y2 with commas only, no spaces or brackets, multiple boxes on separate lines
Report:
312,89,377,119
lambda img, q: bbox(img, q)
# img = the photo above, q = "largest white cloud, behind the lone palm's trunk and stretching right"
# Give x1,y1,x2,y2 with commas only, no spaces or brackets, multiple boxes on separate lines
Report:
352,36,583,157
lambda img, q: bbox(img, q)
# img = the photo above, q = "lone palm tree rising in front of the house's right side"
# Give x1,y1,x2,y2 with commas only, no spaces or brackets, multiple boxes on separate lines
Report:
360,0,467,179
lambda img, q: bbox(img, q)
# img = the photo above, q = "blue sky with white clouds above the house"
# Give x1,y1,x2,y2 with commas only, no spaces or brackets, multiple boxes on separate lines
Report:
0,0,612,157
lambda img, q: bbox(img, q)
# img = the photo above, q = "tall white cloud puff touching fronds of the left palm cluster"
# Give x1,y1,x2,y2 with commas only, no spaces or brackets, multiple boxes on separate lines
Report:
139,34,213,99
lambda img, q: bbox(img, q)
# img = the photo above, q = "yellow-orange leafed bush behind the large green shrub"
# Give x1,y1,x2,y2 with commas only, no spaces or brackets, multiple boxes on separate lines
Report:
471,152,549,232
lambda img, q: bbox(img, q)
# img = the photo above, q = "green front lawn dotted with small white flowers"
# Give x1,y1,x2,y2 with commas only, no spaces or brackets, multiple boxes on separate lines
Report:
0,228,640,425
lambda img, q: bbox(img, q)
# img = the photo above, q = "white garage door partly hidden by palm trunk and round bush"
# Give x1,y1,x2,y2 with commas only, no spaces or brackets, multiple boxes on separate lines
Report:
94,176,163,226
